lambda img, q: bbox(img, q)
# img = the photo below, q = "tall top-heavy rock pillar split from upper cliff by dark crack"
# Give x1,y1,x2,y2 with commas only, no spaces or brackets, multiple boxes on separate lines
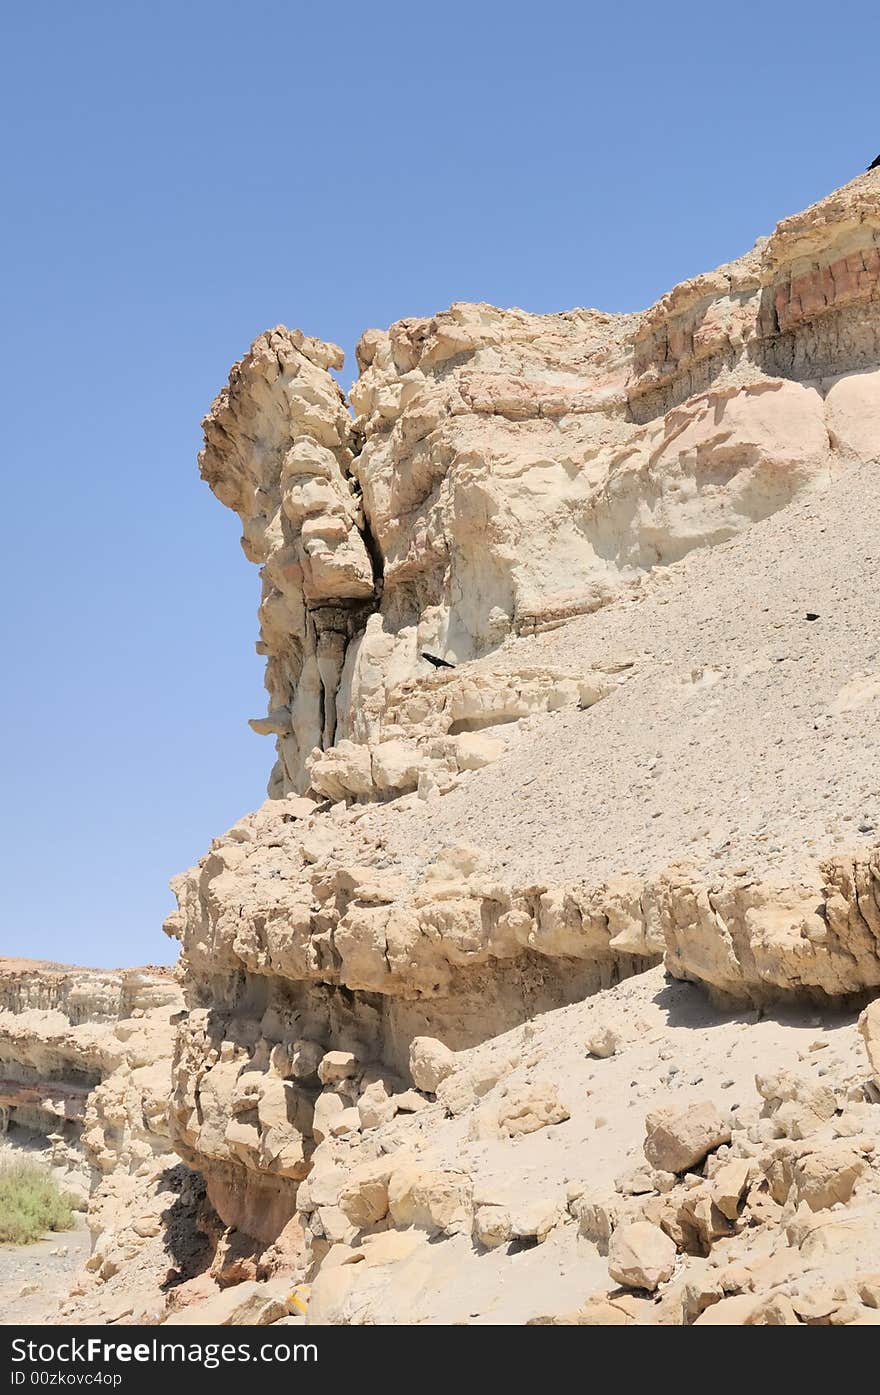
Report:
199,319,377,792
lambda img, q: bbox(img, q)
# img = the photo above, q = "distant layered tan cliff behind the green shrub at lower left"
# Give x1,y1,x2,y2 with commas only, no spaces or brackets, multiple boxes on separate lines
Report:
0,960,210,1321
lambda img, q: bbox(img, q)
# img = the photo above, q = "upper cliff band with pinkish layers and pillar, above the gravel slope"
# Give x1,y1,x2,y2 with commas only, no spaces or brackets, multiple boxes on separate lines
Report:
201,174,880,799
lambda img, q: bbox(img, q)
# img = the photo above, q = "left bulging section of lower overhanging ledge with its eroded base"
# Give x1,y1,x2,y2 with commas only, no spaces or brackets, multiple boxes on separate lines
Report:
169,801,661,1243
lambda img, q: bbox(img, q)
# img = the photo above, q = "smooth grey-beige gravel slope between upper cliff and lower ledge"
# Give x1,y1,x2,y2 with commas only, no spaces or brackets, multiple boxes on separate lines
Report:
363,465,880,883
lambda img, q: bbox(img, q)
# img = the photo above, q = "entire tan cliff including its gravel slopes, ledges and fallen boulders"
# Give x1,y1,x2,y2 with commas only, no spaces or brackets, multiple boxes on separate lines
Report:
18,172,880,1325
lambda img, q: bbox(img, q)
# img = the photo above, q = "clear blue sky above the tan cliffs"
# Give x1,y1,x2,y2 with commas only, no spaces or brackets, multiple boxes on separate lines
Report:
0,0,880,965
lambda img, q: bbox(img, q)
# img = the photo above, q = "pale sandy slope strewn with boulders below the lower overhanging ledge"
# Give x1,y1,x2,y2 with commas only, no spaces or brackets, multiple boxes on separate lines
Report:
232,968,880,1325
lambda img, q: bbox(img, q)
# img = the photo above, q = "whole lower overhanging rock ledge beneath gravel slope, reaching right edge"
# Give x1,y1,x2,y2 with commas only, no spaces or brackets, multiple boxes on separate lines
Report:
161,825,880,1253
